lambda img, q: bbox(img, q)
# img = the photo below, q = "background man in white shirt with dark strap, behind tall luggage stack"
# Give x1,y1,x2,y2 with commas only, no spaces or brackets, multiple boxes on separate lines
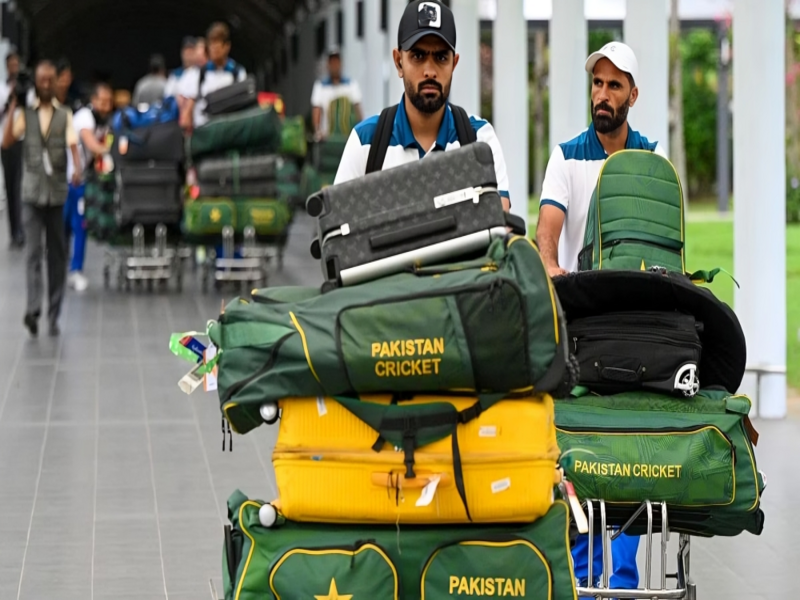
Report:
180,22,247,132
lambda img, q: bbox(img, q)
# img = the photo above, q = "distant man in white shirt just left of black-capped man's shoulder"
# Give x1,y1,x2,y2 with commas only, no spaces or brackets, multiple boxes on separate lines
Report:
311,48,364,140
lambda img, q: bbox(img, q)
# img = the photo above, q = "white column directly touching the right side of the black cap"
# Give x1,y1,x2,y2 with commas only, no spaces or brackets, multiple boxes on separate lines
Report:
450,0,481,115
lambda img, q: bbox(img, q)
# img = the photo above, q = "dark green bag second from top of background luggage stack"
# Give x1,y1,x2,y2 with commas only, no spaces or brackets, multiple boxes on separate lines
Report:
189,107,281,159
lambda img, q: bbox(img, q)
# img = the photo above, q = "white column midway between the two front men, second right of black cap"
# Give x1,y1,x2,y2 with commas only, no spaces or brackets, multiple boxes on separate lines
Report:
492,0,529,230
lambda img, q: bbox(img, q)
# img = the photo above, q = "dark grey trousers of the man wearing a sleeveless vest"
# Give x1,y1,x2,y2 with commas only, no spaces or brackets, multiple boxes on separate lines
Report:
23,204,67,325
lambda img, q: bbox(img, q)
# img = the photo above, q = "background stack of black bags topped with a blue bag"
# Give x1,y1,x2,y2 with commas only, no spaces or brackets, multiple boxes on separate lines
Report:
112,98,184,229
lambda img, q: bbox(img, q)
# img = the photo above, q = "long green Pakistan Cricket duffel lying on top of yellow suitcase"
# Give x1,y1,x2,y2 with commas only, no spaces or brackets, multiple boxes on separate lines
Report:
208,237,569,433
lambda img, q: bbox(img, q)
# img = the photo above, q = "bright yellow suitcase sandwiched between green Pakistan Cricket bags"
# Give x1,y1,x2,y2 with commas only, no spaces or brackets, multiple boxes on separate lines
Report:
273,394,560,524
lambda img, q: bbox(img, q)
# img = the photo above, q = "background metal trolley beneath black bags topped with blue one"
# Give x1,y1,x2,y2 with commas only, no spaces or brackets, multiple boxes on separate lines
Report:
103,223,191,292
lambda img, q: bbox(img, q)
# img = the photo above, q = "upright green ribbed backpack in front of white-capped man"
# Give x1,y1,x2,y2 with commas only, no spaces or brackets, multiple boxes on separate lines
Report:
578,150,686,273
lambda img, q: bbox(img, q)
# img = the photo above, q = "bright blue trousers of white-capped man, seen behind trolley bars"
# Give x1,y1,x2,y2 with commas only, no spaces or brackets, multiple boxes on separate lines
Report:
572,534,639,590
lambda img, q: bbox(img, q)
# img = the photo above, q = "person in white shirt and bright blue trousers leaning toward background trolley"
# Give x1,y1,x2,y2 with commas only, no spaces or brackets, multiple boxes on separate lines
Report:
64,83,114,292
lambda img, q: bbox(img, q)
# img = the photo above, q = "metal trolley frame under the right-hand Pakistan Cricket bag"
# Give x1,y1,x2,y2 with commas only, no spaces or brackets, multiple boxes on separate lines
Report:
578,500,697,600
